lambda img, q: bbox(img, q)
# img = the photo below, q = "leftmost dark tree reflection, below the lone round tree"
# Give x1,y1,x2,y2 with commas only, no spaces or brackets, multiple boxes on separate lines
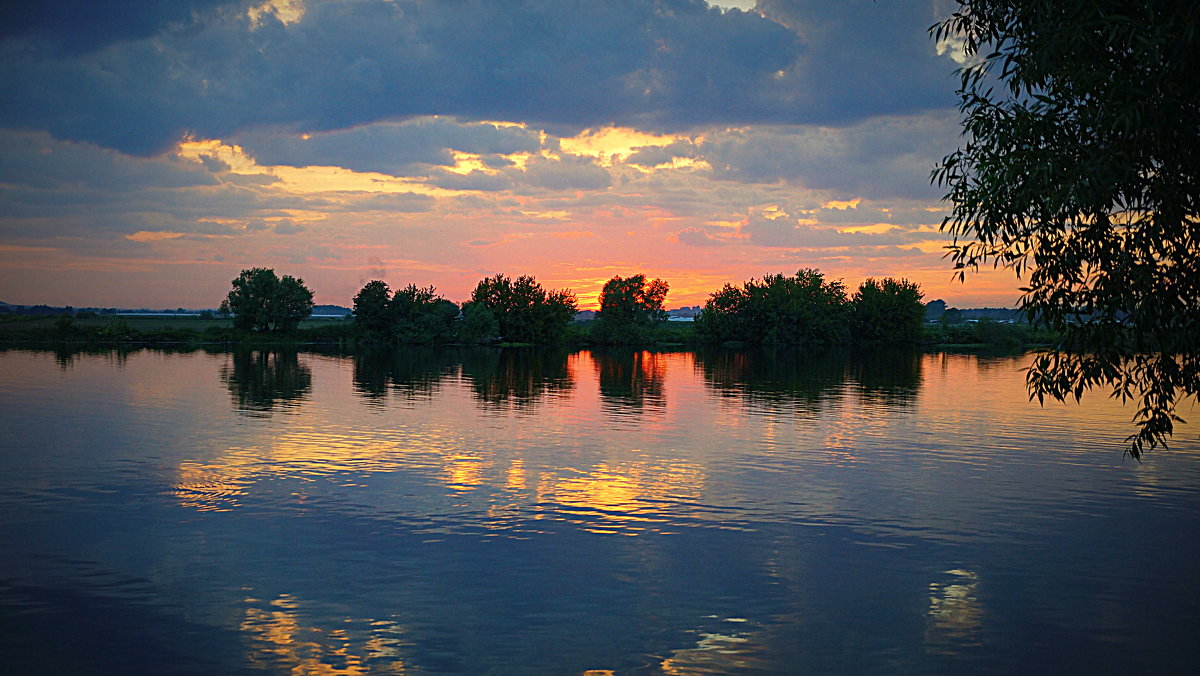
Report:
221,351,312,415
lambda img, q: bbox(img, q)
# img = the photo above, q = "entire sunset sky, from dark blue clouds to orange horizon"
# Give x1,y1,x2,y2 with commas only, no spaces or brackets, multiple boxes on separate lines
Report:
0,0,1019,307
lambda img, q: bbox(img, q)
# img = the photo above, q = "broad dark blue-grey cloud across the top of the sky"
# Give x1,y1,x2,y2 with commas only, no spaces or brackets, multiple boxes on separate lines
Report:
0,0,949,156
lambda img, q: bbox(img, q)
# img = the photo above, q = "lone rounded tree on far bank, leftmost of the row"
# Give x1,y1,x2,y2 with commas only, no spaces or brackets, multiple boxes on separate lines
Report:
221,268,312,333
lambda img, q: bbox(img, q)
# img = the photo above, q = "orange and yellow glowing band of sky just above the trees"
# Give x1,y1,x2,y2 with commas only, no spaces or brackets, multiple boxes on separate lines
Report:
9,121,1018,309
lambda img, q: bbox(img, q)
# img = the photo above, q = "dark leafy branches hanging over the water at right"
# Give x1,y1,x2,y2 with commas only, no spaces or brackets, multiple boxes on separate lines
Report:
931,0,1200,457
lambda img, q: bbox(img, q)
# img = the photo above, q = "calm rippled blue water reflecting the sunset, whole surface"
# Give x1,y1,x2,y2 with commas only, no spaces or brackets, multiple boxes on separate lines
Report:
0,349,1200,675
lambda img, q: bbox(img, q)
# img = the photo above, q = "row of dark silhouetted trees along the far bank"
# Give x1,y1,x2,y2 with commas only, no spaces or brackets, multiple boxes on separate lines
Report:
221,268,925,348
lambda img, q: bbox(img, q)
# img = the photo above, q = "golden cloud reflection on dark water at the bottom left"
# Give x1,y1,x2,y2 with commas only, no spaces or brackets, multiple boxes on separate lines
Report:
239,594,406,676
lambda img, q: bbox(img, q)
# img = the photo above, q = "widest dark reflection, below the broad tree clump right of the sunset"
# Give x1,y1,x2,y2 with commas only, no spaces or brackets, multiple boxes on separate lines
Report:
696,349,850,413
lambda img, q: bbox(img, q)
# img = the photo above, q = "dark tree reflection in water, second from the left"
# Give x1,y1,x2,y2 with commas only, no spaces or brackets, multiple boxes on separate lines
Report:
354,347,460,403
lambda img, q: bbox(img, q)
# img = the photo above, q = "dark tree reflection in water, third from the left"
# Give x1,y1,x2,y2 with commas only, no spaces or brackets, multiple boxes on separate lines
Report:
462,348,575,409
